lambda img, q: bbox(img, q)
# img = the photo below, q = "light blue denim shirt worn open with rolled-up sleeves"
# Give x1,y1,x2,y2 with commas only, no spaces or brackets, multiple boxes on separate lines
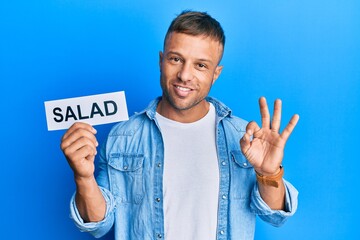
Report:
70,97,298,240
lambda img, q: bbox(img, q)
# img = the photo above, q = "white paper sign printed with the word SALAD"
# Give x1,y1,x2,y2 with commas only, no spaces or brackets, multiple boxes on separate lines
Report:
45,91,129,131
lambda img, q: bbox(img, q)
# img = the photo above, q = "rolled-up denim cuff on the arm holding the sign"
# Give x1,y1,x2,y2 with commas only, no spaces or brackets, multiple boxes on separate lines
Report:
70,187,115,238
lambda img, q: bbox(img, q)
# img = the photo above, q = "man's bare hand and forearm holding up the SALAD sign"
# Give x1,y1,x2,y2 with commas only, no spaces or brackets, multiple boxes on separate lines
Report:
60,123,106,222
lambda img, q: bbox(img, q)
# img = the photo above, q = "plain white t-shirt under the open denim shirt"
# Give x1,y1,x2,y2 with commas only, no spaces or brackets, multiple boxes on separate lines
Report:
156,103,219,240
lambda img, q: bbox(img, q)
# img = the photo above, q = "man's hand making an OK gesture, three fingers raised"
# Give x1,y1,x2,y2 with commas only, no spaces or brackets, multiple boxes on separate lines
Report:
240,97,299,176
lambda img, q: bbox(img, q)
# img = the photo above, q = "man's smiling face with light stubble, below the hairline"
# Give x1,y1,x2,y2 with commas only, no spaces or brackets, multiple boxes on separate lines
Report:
160,32,223,120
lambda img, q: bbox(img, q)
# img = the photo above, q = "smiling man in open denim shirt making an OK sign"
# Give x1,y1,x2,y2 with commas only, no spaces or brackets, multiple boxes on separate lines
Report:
61,11,299,240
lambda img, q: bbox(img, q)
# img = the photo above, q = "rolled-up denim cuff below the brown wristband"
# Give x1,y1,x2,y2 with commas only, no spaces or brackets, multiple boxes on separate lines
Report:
250,180,298,227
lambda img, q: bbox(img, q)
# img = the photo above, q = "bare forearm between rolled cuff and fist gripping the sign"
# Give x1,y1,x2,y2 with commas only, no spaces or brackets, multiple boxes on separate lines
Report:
75,174,106,222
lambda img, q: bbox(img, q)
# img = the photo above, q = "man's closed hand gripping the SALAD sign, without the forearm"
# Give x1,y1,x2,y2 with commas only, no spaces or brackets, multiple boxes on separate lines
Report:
60,122,98,179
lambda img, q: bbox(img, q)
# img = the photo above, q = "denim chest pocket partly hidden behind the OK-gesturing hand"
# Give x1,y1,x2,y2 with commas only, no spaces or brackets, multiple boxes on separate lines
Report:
230,151,255,200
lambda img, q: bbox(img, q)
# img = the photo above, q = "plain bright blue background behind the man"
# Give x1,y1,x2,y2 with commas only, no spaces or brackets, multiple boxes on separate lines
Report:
0,0,360,240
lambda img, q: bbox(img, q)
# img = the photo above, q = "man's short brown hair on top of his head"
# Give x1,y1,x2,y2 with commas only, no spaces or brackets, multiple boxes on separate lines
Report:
164,10,225,49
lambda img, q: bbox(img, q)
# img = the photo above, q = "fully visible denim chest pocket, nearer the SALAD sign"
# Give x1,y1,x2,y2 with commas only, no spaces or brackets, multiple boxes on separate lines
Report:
109,153,144,204
